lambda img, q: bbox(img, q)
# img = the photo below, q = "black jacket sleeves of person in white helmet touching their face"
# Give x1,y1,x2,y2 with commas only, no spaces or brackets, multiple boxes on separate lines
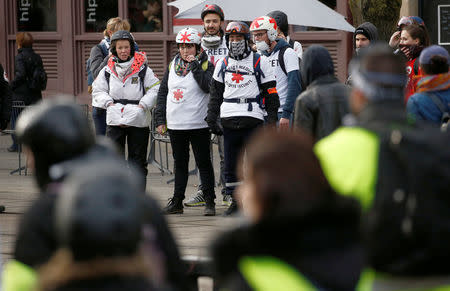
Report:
155,52,214,127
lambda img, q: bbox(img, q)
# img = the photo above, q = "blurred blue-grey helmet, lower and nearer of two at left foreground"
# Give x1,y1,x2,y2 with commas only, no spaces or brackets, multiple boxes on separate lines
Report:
54,160,145,261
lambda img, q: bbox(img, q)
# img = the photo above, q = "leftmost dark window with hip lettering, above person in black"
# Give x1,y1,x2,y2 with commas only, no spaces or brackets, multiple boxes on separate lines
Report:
17,0,56,31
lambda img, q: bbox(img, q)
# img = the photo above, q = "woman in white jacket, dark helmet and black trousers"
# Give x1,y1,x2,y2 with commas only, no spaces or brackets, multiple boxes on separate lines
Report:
92,30,159,185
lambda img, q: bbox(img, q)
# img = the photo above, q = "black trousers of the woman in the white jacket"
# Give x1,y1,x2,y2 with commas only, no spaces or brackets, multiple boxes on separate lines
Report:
106,125,150,185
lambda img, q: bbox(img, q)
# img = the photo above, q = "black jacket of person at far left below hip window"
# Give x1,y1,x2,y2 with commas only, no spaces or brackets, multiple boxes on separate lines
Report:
11,48,43,105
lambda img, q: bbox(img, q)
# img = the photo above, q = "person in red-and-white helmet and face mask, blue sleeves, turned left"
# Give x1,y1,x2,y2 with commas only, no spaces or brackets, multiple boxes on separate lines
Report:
250,16,302,129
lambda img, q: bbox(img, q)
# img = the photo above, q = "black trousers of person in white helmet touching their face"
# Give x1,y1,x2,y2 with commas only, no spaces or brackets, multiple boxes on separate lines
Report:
169,128,216,201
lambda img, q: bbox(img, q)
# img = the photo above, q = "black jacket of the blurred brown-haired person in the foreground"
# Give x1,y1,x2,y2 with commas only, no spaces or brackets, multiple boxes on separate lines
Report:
212,197,364,291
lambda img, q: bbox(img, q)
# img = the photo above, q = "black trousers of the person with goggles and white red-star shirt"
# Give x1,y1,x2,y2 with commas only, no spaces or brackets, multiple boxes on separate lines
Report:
223,126,258,195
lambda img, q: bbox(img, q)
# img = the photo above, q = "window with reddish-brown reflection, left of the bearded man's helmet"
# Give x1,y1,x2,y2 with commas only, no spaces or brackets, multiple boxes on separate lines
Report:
128,0,163,32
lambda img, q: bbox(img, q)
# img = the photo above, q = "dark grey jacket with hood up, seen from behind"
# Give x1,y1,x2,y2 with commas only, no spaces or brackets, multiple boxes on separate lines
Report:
294,45,350,140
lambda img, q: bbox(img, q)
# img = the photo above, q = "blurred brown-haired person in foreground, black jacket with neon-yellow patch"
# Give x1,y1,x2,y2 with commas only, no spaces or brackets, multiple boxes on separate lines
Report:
212,128,363,290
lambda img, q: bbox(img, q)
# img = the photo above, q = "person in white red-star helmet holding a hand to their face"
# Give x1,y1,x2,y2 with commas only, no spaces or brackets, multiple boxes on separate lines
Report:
155,27,216,216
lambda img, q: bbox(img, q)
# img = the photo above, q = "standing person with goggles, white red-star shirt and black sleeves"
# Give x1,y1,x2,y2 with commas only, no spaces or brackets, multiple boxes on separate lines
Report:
206,22,279,215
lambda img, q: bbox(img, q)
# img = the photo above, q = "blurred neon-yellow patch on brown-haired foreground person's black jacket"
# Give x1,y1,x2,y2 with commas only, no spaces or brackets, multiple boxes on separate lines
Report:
239,257,318,291
